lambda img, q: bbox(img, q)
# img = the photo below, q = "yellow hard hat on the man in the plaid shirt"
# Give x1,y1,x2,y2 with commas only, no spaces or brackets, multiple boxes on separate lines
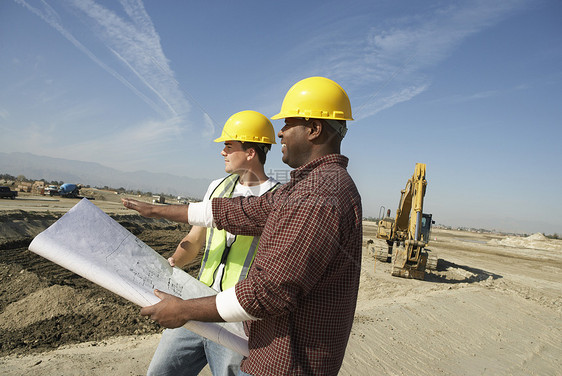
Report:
271,77,353,120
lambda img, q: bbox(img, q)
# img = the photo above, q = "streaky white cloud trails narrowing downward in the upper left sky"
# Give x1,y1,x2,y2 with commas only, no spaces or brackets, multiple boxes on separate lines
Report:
15,0,191,123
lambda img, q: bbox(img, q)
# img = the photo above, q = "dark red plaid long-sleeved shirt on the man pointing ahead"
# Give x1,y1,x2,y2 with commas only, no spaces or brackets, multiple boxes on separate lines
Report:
212,154,362,376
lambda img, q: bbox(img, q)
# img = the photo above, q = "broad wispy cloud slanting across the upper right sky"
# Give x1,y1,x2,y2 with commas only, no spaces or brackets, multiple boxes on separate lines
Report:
315,0,529,119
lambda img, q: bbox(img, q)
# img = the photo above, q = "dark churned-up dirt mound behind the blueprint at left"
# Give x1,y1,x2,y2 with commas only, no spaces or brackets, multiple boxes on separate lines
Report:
0,211,200,356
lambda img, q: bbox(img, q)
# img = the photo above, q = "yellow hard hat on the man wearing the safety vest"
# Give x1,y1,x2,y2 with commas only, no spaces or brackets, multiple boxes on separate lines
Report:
215,110,275,144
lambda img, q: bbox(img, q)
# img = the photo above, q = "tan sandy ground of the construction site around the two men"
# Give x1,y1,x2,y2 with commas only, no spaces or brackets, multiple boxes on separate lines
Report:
0,192,562,376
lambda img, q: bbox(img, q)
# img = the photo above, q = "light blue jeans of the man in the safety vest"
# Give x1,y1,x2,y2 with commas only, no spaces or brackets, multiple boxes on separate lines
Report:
147,327,243,376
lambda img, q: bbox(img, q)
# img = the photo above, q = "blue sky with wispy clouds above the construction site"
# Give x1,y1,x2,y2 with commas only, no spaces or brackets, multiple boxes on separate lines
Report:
0,0,562,234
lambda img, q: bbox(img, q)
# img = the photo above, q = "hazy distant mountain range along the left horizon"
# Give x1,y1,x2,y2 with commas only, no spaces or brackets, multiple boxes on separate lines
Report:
0,152,210,199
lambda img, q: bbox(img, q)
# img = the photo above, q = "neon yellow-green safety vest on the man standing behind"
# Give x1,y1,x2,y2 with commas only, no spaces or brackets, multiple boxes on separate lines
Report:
198,174,279,291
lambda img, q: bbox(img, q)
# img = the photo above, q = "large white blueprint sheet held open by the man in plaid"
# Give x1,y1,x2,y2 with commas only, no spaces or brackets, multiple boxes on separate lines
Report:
29,199,249,356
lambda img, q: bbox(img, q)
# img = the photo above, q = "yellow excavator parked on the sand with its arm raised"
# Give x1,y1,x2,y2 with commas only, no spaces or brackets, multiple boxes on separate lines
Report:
375,163,438,279
